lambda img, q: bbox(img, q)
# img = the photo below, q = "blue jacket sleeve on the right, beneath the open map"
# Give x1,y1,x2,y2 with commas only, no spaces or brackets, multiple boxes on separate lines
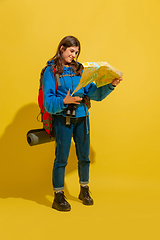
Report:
84,83,115,101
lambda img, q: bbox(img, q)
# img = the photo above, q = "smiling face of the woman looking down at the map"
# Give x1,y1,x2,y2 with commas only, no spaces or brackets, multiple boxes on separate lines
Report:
61,46,79,64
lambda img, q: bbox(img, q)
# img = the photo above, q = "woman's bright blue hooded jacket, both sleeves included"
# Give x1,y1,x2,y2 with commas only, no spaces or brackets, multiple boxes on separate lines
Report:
43,61,114,117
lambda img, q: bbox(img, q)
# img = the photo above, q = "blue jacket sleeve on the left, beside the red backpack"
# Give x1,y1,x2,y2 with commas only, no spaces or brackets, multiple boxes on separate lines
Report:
43,67,67,114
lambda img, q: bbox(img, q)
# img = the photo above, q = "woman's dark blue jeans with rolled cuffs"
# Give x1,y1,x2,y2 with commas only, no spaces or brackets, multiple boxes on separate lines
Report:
53,116,90,190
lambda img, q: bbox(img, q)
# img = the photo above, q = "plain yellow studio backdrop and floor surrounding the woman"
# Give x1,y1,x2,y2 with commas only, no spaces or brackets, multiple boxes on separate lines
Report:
0,0,160,240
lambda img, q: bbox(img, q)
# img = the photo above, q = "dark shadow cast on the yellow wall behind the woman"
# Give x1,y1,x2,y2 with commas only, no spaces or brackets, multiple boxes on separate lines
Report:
0,103,94,206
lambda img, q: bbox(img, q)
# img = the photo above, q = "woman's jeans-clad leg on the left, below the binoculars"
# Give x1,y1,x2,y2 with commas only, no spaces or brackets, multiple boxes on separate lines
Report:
52,116,73,191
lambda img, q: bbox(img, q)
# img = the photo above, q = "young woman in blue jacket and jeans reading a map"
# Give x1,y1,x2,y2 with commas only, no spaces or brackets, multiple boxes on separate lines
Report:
43,36,122,211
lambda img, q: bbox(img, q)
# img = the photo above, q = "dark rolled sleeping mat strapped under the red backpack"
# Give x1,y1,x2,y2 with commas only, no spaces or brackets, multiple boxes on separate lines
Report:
27,128,55,146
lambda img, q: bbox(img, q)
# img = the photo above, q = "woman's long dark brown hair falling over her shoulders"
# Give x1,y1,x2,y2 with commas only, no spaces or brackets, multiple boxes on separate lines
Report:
50,36,83,75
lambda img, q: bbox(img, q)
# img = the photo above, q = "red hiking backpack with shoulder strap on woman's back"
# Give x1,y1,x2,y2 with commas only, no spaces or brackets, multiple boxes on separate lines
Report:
38,65,60,137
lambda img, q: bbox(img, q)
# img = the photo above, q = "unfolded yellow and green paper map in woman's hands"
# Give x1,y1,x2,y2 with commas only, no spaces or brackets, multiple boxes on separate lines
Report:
71,62,123,96
